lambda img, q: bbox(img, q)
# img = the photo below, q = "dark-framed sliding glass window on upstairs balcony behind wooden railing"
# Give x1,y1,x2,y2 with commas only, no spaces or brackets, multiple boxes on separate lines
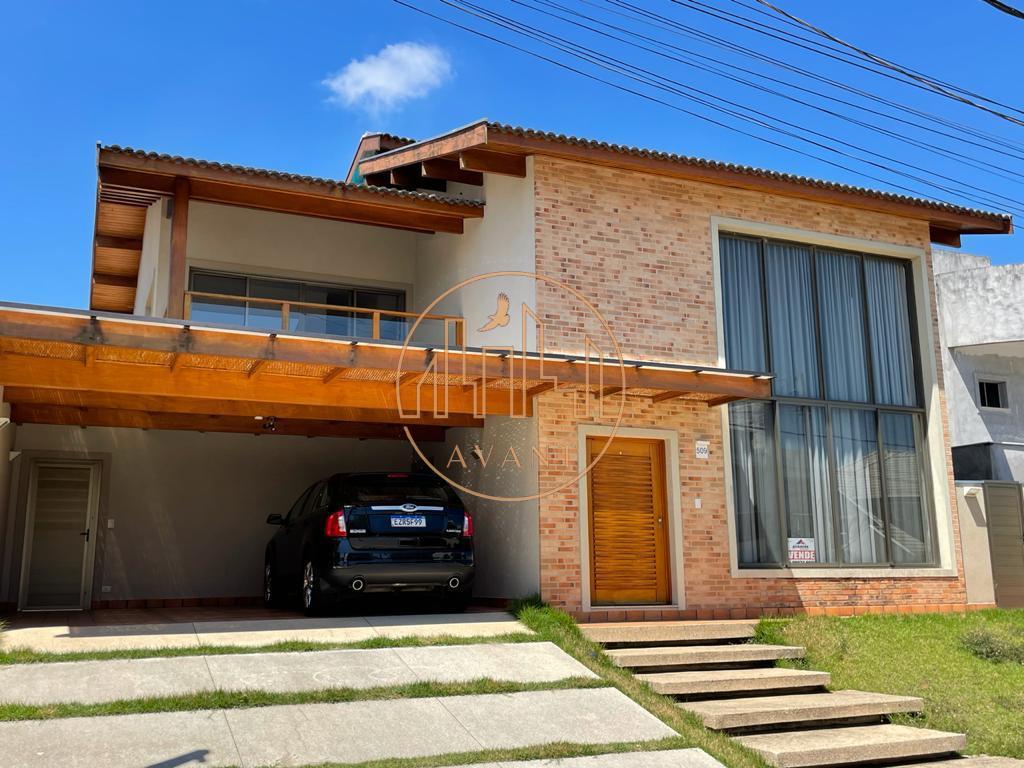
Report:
189,269,406,341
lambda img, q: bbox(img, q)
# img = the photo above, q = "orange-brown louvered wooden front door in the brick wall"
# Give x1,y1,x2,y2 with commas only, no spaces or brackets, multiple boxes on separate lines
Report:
587,437,671,605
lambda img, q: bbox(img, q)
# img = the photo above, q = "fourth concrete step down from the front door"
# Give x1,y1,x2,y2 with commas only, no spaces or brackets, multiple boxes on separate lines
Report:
679,690,924,730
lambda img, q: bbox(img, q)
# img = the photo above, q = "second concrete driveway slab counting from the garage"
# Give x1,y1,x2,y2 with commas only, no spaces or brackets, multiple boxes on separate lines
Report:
0,642,597,706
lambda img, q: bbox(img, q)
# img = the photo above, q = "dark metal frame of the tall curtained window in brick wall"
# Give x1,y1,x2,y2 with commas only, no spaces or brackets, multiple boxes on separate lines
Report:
712,233,937,572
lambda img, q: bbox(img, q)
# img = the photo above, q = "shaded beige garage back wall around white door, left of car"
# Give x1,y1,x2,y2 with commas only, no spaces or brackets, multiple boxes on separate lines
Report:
0,425,411,602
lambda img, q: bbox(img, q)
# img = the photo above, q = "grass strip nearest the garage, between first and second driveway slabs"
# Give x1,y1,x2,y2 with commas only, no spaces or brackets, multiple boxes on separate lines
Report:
0,632,539,666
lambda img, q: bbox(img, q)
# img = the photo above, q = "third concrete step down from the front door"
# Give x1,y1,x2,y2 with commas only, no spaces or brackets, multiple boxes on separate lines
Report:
637,667,831,696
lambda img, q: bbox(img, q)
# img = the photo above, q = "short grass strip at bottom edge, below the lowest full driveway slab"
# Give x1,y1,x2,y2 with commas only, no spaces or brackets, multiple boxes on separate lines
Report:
280,736,689,768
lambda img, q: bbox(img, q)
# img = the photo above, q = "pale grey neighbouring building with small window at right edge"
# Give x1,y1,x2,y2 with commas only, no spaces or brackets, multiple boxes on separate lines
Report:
933,250,1024,482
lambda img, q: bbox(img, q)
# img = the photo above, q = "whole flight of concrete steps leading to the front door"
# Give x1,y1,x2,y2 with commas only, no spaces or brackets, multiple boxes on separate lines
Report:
581,620,987,768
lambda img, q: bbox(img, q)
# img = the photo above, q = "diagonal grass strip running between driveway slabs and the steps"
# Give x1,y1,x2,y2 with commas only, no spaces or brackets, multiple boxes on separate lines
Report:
499,599,765,768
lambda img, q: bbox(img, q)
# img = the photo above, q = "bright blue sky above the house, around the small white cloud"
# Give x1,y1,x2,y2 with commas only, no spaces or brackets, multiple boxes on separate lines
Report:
0,0,1024,306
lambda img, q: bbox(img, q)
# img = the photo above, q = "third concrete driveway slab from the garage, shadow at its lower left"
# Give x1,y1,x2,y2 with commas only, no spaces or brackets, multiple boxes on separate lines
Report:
0,688,679,768
